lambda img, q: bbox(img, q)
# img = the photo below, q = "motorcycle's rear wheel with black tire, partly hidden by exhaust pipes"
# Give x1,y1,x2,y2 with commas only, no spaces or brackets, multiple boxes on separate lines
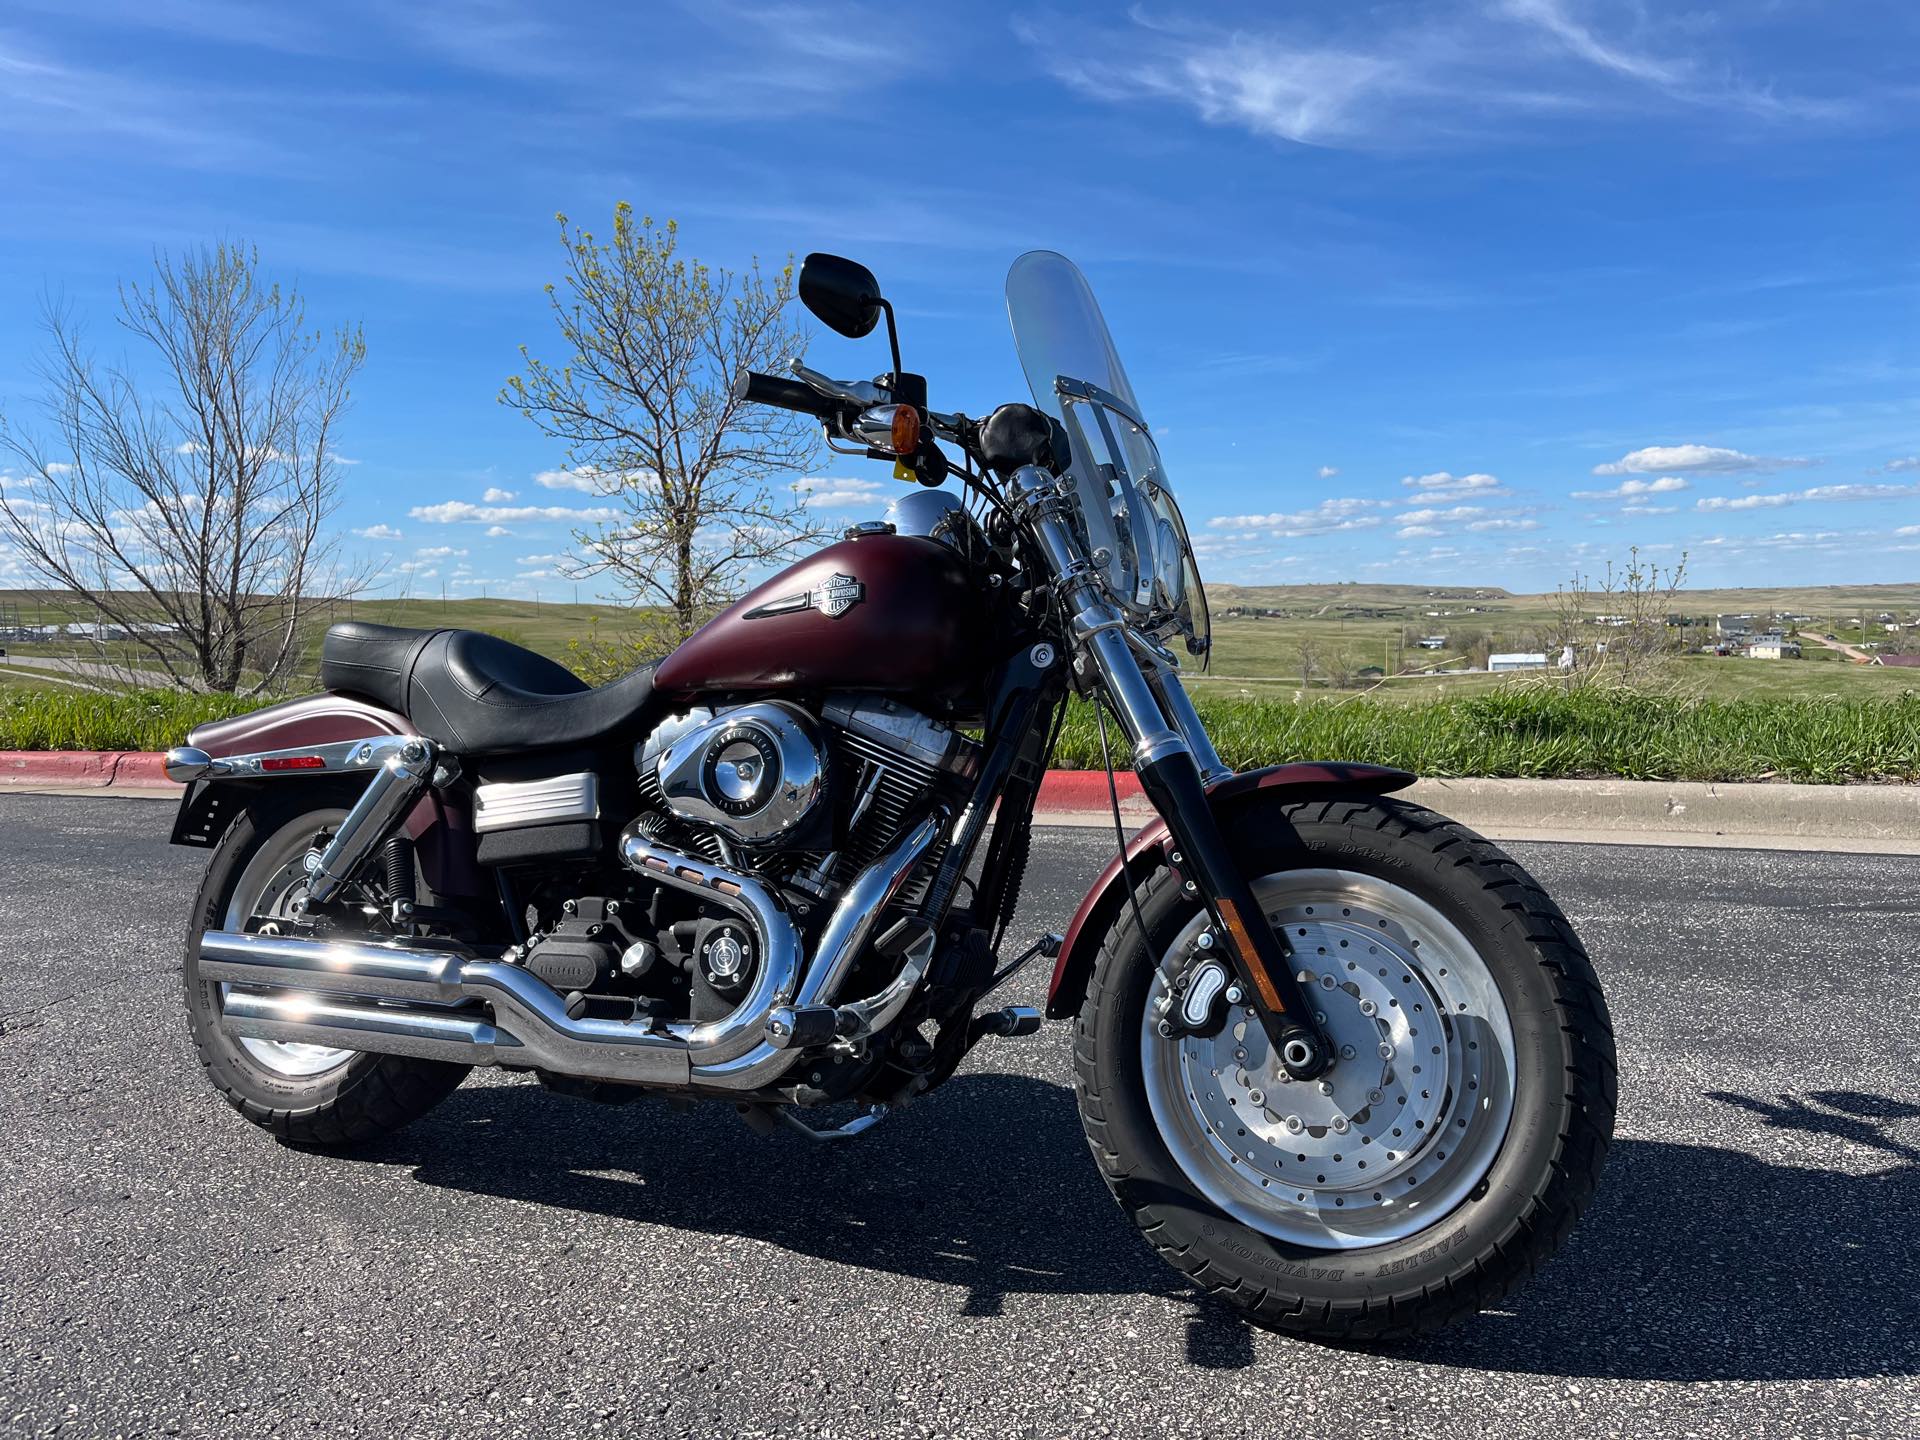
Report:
182,795,468,1146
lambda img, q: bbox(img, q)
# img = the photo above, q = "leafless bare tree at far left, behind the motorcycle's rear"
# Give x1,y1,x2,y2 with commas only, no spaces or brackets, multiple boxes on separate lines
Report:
0,244,367,695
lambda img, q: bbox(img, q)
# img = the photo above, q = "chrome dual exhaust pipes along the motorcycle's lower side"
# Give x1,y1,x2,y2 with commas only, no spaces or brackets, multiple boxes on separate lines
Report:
198,812,947,1096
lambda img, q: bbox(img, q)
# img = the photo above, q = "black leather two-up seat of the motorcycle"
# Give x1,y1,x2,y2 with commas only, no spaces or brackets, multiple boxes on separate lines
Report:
321,620,653,755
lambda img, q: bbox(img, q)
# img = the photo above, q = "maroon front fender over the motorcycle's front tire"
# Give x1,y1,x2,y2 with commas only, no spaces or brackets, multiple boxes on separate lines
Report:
1046,760,1419,1020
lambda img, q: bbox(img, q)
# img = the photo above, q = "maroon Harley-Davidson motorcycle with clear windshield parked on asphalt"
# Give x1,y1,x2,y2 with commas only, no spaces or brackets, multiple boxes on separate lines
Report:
167,252,1615,1340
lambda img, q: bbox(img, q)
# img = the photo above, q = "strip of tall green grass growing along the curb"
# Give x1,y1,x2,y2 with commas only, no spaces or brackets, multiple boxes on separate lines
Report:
0,685,1920,785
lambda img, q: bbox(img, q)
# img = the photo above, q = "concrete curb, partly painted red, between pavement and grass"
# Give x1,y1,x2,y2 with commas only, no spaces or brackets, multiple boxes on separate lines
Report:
0,751,1920,854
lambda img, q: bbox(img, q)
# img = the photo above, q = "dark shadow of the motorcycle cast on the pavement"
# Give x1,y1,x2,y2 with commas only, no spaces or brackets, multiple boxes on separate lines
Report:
382,1073,1920,1380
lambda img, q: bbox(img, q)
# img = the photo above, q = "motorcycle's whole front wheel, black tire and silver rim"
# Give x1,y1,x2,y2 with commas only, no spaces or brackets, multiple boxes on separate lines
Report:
1075,797,1615,1340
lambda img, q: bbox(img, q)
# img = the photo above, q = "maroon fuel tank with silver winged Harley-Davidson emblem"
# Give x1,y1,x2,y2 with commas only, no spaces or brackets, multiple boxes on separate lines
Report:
653,536,993,707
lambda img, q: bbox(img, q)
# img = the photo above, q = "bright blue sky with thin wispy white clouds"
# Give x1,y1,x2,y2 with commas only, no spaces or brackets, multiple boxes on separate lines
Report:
0,0,1920,599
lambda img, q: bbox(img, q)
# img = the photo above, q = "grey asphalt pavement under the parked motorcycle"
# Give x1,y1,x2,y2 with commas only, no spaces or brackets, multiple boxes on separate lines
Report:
0,795,1920,1440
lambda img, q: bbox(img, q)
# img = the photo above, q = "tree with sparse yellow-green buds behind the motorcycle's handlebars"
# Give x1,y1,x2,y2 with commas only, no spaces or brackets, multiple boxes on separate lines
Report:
501,202,826,643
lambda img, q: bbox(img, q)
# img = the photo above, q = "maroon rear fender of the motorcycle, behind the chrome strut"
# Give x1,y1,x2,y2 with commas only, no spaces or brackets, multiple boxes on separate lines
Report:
169,695,484,897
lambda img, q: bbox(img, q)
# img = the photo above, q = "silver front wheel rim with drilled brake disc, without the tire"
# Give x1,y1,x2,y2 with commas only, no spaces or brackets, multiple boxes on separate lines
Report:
1140,870,1515,1250
